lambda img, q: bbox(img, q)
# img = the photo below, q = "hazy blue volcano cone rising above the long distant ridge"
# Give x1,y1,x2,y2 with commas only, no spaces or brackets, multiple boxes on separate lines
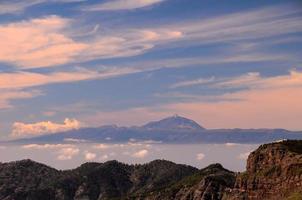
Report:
142,115,205,131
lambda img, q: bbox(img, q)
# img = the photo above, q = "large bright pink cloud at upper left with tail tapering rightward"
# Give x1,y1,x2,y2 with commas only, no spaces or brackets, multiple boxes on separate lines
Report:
0,16,182,68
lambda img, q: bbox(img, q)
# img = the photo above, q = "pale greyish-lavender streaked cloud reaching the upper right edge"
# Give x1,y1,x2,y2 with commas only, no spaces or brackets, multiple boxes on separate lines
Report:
171,6,302,43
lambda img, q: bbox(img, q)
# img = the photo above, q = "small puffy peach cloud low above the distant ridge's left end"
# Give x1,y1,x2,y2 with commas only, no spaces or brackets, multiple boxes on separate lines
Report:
11,118,80,137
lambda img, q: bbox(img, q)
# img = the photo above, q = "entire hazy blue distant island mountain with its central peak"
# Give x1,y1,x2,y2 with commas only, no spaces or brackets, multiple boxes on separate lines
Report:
5,116,302,144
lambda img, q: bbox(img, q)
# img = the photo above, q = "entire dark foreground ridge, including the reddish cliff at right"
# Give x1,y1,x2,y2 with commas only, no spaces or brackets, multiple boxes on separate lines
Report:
0,140,302,200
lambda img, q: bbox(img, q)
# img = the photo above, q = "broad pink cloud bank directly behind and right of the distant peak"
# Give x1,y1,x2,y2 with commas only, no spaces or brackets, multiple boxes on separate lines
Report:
82,71,302,130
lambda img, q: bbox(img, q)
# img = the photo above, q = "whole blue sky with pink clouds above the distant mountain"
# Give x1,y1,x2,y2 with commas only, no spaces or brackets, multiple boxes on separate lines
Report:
0,0,302,139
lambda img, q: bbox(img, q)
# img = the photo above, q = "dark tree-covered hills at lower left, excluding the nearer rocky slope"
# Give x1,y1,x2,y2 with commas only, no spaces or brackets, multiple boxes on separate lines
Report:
0,160,198,200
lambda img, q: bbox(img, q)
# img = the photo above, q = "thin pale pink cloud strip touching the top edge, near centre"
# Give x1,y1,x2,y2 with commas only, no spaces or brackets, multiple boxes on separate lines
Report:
83,0,164,11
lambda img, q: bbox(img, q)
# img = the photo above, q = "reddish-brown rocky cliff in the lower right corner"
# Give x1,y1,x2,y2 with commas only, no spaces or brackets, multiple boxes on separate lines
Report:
227,140,302,200
